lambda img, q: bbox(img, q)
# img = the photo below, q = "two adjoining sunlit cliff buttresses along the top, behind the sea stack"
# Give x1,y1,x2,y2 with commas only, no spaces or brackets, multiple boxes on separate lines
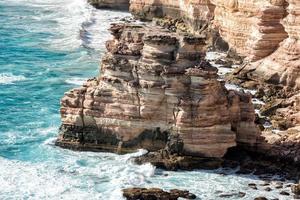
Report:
130,0,287,61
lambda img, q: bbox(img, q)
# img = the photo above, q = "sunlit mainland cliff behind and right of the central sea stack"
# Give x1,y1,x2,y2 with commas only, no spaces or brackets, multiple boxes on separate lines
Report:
127,0,300,162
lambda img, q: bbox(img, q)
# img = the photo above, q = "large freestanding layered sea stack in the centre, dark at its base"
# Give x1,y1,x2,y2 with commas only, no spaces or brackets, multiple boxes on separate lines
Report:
56,24,258,157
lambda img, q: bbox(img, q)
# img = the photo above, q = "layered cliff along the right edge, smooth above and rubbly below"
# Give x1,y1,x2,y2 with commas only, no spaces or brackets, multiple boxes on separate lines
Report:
232,0,300,163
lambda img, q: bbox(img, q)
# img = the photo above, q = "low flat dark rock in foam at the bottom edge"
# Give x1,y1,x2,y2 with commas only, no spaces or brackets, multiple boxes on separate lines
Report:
123,188,196,200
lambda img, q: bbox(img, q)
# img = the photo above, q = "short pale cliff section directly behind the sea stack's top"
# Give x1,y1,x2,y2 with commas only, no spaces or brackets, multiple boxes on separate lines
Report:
130,0,214,30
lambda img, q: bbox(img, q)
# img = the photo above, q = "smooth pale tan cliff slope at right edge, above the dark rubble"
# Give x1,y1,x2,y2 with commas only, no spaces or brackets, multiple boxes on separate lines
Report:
243,0,300,90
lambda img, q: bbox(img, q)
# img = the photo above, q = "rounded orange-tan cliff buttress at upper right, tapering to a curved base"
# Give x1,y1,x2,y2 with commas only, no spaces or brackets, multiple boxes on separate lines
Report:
211,0,287,61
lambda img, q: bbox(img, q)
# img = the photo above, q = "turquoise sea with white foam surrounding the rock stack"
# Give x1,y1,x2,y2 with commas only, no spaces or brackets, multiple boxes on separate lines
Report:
0,0,289,200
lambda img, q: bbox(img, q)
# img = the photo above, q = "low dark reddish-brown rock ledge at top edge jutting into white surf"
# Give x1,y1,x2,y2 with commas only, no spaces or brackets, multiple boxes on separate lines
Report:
88,0,129,10
